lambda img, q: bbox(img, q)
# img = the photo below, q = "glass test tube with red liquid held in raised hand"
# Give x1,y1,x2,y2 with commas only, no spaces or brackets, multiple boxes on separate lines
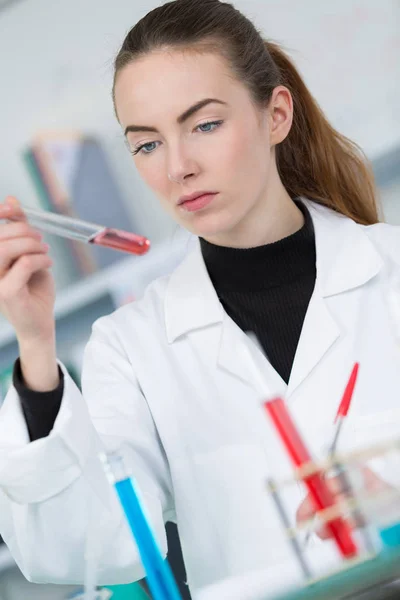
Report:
7,206,150,255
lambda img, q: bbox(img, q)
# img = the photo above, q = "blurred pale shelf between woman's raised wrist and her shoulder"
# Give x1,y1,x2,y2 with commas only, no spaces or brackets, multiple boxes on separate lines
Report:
0,238,188,349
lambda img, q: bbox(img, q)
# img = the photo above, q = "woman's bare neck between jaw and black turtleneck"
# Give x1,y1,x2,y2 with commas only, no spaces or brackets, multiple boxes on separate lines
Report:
204,161,304,248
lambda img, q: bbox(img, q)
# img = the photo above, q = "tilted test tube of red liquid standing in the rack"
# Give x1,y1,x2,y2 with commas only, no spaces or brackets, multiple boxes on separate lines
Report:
264,398,357,558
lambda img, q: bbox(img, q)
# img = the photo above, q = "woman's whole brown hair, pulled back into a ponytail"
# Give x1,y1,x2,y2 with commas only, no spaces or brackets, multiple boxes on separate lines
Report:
113,0,378,225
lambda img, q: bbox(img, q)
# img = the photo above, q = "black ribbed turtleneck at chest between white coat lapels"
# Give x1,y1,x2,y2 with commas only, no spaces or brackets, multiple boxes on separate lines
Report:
200,202,316,383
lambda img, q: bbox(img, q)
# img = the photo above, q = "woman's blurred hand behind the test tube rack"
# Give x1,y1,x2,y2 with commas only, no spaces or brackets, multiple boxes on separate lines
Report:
296,467,391,540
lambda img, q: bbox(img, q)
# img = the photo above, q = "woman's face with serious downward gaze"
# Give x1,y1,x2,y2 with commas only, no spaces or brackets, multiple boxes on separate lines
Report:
115,51,288,243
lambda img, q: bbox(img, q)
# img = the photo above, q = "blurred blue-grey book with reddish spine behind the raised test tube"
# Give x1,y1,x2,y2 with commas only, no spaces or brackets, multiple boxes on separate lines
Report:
24,132,139,275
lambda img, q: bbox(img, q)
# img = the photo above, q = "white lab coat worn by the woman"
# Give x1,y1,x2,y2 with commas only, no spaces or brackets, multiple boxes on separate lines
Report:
0,200,400,597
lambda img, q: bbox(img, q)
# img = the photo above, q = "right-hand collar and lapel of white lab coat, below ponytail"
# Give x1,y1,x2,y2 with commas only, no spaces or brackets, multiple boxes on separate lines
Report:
287,199,383,397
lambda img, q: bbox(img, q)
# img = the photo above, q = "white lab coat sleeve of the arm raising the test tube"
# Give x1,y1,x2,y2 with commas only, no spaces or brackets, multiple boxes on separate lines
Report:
0,317,173,584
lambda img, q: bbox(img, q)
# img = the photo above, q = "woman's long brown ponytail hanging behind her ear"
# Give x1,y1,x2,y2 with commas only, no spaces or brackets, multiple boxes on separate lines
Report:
264,42,378,225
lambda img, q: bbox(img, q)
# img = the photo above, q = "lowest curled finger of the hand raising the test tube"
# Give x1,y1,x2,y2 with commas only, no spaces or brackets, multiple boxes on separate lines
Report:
0,254,53,300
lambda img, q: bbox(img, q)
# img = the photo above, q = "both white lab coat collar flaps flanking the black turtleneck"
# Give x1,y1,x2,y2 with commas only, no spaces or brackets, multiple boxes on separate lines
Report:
164,198,383,343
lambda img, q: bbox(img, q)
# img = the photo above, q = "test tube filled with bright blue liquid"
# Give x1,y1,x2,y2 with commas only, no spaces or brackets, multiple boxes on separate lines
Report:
101,453,182,600
